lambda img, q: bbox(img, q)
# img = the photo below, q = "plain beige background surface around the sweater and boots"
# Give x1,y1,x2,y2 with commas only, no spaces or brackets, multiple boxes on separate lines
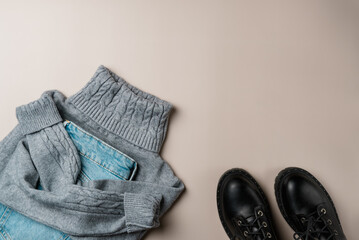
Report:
0,0,359,240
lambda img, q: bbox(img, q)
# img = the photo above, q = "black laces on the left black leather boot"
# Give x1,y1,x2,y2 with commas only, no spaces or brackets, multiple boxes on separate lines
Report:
235,210,272,240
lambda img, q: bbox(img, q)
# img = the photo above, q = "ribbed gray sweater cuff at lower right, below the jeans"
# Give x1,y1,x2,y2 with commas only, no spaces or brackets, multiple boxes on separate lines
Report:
124,193,162,233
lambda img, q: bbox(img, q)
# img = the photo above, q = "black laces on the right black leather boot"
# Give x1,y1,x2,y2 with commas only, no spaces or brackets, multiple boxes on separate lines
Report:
293,208,338,240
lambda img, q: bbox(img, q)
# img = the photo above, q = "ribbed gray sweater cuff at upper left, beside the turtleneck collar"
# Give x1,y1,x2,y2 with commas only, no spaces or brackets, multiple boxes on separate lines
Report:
16,93,62,135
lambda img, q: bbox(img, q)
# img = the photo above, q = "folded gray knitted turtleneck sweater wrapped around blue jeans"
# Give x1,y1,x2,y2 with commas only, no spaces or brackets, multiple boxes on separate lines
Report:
0,66,184,240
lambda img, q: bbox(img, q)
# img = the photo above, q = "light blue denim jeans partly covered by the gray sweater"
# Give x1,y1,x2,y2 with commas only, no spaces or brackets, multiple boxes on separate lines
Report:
0,121,137,240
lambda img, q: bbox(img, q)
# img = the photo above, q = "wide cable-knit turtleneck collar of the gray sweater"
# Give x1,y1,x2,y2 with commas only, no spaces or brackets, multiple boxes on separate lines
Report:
69,66,172,152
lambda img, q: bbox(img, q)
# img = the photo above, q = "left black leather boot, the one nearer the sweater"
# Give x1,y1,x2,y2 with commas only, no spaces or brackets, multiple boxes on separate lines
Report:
217,169,277,240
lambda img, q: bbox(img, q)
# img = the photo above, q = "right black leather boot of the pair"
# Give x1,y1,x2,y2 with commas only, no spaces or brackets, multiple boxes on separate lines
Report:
275,168,346,240
